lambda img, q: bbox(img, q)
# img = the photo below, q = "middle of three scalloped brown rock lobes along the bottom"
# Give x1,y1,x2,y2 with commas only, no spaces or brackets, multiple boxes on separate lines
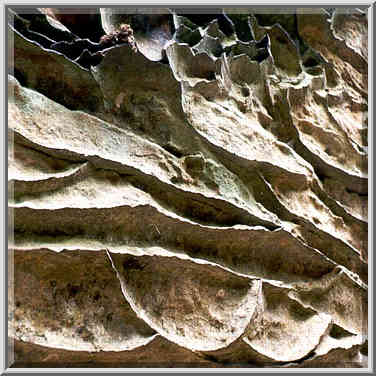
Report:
108,253,261,351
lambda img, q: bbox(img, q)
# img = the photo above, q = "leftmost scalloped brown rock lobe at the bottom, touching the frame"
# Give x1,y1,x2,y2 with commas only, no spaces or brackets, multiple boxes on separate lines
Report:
9,249,157,352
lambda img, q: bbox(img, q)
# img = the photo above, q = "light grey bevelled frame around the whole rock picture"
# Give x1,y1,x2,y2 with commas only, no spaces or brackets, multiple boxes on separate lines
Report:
0,0,375,375
